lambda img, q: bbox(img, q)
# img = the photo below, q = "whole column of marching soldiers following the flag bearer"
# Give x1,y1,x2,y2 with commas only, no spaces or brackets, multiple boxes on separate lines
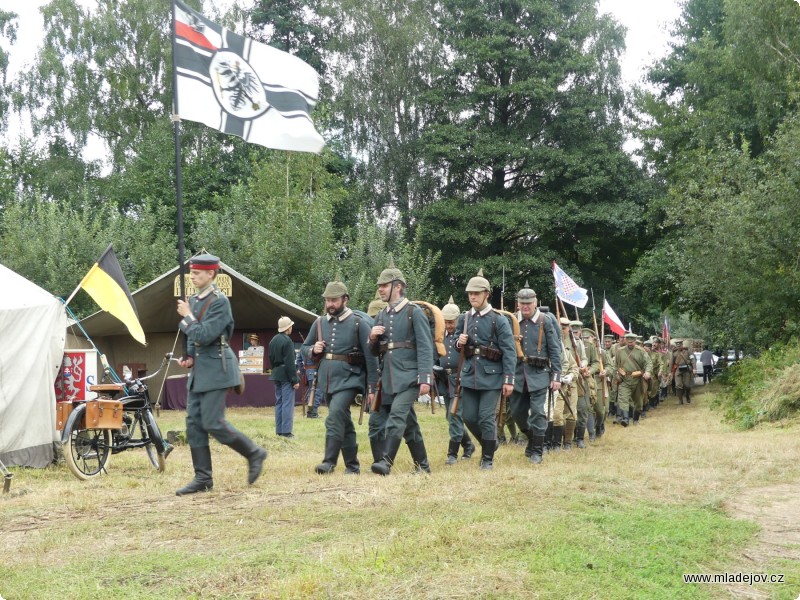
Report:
301,264,694,476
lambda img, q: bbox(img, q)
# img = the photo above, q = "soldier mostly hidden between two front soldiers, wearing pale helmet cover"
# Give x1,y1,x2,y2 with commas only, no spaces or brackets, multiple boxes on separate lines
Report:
434,296,475,465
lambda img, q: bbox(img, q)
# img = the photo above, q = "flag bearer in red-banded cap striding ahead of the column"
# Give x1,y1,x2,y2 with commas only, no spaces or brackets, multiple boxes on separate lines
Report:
175,254,267,496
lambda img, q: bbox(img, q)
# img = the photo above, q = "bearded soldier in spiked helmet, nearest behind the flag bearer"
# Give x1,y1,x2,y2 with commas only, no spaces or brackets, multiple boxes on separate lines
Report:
301,281,378,475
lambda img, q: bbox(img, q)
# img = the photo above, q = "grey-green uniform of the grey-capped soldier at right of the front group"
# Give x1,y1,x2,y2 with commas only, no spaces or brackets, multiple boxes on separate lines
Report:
511,308,563,436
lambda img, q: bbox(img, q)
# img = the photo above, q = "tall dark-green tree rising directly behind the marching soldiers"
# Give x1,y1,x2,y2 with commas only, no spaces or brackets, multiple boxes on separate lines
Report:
419,0,649,300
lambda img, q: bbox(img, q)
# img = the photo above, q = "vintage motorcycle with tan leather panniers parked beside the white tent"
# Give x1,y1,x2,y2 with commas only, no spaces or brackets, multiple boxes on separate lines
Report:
60,352,177,480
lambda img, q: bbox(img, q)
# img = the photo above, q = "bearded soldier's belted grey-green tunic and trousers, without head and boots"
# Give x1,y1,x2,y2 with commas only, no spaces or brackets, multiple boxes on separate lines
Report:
301,308,378,454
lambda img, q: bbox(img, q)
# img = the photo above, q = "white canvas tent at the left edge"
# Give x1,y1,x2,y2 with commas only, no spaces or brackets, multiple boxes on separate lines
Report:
0,264,67,467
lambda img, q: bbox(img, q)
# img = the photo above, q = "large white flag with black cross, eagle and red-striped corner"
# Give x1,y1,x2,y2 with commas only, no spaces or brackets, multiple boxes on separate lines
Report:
172,0,325,152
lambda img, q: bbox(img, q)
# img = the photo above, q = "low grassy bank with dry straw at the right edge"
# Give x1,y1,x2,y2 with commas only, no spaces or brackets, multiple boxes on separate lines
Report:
718,339,800,429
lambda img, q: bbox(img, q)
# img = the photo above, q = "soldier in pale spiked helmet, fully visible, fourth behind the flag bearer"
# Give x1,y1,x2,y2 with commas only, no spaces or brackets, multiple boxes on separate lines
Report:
456,271,517,470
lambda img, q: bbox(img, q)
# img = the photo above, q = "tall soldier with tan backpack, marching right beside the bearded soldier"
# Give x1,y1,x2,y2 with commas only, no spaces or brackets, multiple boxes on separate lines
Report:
369,264,434,475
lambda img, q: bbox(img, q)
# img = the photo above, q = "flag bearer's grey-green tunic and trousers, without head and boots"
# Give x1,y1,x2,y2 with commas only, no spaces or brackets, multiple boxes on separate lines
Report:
179,284,249,448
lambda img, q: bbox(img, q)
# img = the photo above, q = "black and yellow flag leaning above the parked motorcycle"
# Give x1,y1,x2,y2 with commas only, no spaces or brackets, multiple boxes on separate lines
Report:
78,245,147,345
